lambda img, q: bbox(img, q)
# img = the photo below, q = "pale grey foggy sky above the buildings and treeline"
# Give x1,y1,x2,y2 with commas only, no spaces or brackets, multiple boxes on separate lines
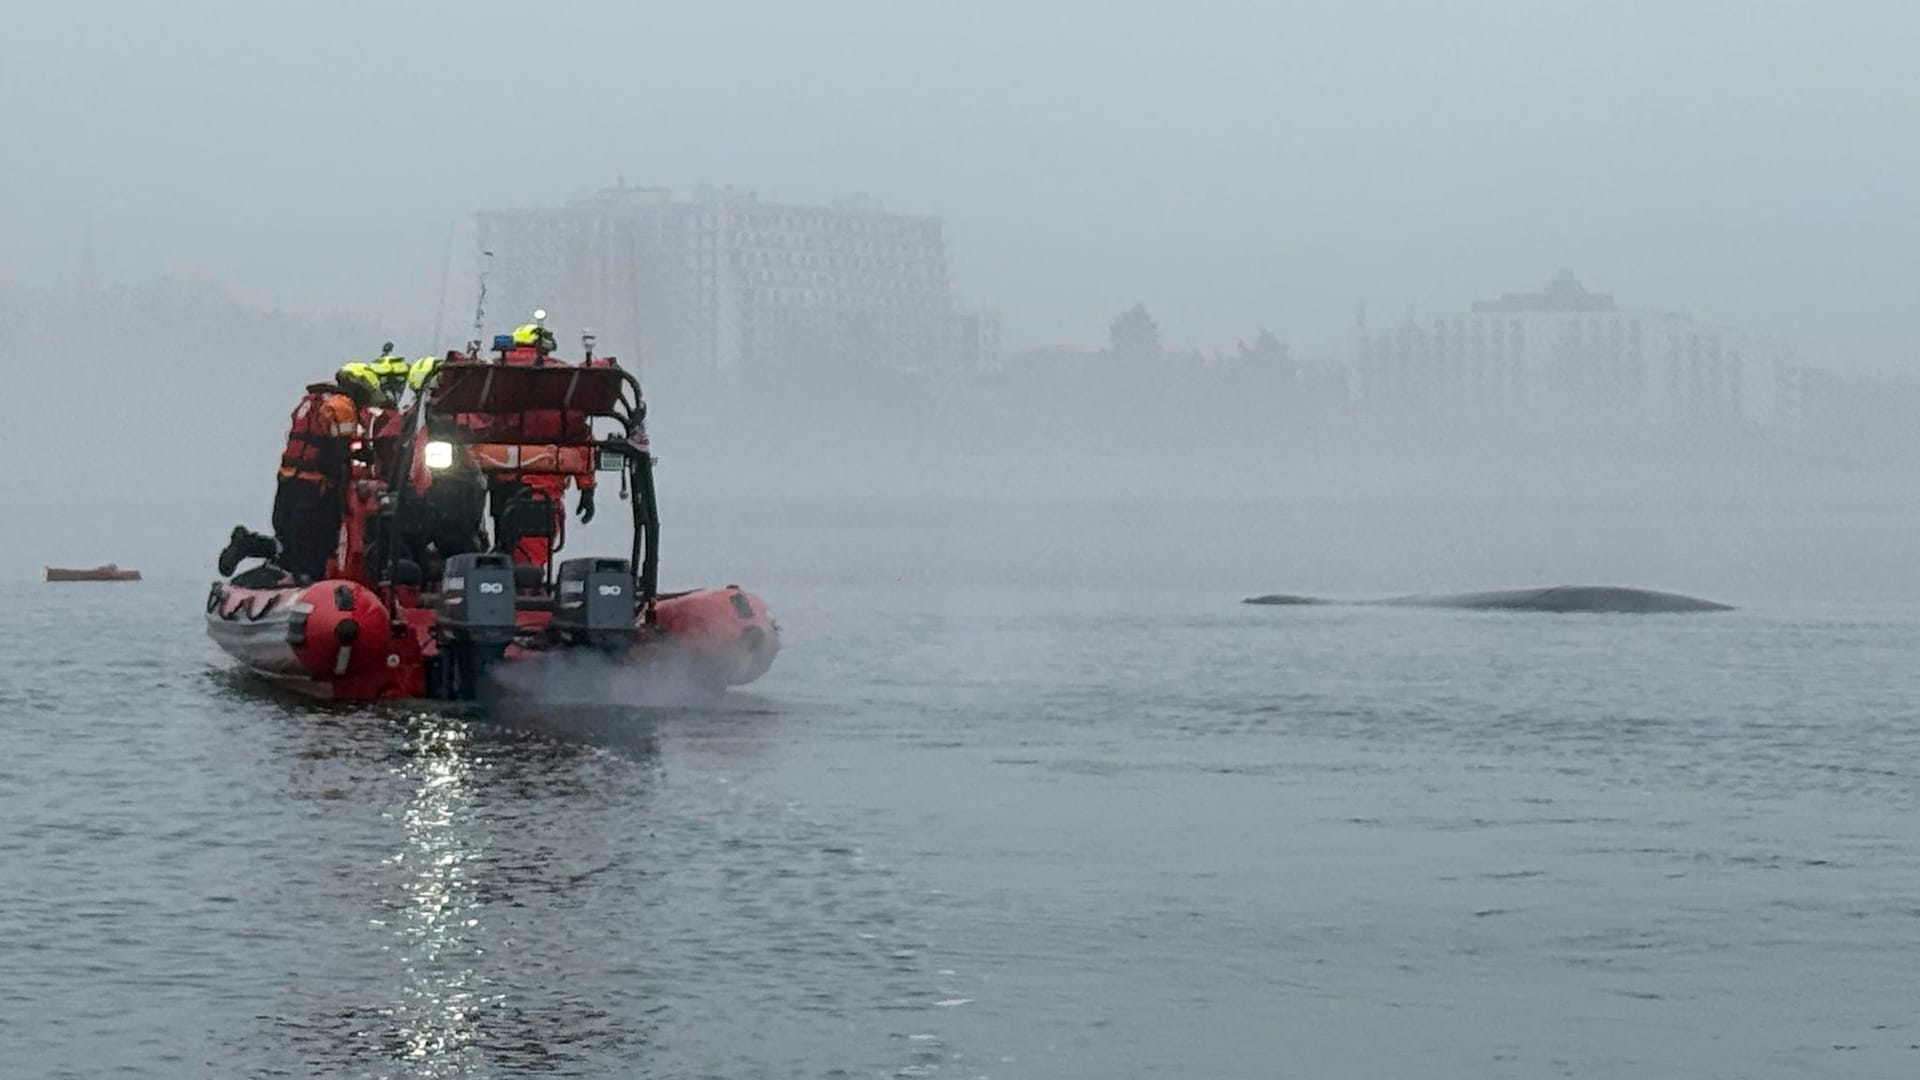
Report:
0,0,1920,365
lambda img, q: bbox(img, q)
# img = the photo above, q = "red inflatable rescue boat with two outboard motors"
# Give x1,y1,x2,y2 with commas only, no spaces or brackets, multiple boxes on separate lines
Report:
205,340,780,701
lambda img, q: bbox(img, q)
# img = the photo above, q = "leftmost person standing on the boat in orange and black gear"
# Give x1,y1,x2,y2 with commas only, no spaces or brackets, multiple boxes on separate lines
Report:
273,369,376,580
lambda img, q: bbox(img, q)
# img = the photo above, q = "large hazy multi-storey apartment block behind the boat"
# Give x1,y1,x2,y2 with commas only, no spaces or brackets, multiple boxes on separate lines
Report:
478,183,1000,375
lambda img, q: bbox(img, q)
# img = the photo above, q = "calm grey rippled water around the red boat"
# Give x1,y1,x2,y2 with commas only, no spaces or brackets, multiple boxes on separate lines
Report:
0,502,1920,1078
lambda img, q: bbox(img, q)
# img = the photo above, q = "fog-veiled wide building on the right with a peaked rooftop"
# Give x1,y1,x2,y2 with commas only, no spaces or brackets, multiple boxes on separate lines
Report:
1352,271,1803,432
